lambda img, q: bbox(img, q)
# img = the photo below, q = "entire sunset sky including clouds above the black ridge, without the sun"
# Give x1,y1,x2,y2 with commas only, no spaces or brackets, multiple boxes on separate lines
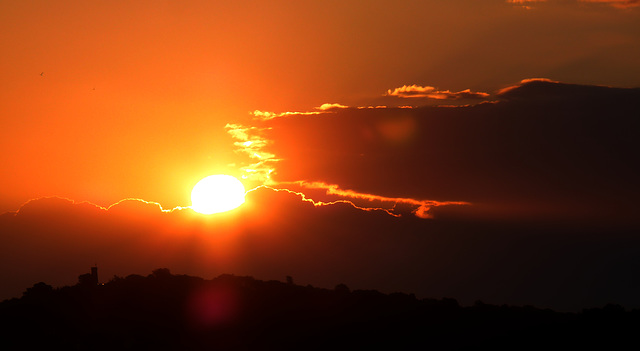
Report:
0,0,640,309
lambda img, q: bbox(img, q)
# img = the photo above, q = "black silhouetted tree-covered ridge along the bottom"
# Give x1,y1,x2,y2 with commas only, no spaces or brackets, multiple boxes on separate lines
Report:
0,268,640,350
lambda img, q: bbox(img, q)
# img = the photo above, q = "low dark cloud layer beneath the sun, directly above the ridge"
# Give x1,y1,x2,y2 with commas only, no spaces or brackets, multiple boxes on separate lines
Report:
0,188,640,310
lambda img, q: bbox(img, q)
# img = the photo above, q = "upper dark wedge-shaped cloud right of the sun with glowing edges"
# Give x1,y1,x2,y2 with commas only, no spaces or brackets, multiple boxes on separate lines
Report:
251,78,640,226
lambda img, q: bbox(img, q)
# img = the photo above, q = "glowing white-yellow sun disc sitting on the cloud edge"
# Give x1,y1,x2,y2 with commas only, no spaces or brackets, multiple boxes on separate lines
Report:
191,174,245,214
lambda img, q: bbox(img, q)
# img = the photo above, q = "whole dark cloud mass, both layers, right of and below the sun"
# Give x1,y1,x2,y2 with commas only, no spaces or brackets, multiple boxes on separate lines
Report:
0,81,640,310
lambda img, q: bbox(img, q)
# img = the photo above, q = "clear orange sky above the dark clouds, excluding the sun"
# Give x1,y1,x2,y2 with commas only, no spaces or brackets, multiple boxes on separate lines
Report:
0,1,640,212
